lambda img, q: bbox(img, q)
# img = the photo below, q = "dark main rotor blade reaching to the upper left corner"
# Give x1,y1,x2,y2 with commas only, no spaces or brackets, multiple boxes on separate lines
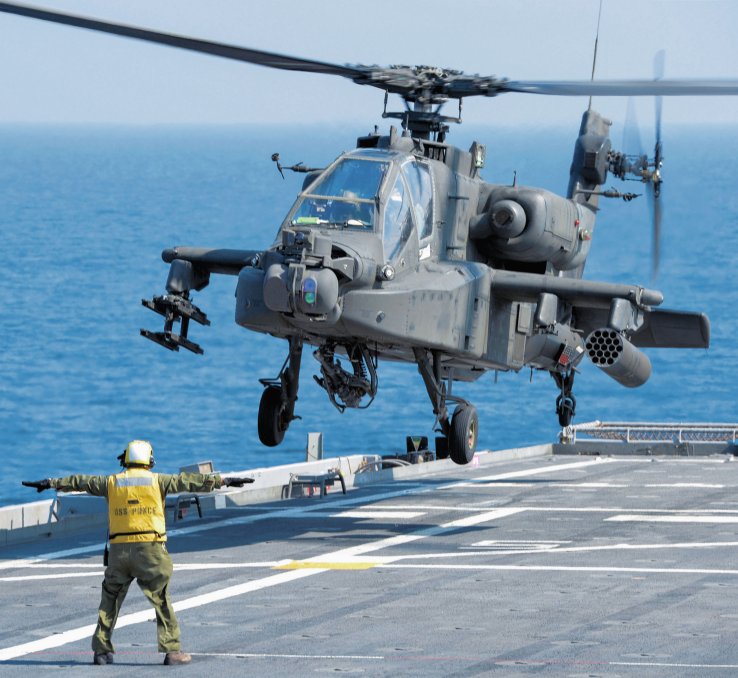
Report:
0,2,368,78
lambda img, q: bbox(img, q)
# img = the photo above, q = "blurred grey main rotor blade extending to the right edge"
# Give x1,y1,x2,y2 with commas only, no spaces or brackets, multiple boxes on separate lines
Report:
499,80,738,97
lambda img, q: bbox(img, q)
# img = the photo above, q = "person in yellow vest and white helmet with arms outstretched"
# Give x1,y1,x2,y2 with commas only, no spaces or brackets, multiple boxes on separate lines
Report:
23,440,253,665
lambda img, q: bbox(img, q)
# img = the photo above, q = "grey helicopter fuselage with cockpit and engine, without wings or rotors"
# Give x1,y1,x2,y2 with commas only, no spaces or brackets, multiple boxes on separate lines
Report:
236,121,594,379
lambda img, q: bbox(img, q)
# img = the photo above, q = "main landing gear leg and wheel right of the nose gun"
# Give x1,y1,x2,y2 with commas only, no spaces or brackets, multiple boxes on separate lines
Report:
413,348,479,464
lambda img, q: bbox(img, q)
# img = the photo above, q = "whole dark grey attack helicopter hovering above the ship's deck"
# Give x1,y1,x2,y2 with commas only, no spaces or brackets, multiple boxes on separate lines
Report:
0,3,738,464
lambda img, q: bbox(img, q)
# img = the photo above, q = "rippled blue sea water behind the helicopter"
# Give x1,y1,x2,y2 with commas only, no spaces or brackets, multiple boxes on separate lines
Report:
0,121,738,504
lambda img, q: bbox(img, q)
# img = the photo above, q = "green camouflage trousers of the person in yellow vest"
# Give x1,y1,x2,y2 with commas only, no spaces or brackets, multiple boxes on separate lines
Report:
92,542,180,652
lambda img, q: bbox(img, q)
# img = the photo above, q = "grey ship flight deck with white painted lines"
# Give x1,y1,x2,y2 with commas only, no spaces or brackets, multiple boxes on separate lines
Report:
0,446,738,678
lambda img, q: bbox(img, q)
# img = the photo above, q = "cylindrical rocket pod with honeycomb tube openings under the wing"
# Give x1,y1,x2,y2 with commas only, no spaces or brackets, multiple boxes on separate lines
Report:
585,327,651,388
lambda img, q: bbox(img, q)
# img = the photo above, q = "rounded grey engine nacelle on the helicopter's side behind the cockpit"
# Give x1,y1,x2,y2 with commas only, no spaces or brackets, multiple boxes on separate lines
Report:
469,186,594,270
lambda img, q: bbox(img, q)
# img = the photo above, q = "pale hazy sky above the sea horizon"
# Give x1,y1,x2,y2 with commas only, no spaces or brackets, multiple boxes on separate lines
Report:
0,0,738,128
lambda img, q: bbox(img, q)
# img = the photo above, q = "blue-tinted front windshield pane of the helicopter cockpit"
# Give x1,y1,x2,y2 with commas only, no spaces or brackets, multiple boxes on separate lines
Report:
292,158,389,229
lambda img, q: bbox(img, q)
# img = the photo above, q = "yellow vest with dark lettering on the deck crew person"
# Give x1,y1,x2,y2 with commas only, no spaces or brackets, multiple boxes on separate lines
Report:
108,468,167,544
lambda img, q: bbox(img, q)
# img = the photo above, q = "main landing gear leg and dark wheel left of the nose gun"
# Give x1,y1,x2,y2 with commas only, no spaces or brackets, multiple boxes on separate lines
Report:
258,337,302,447
